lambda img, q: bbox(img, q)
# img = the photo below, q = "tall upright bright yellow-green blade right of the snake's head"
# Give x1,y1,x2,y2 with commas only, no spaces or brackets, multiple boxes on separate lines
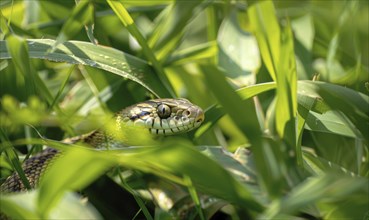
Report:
249,1,296,150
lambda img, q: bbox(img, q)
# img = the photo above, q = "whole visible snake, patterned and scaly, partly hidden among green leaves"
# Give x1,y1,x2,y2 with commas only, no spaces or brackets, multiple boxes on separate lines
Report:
0,98,204,193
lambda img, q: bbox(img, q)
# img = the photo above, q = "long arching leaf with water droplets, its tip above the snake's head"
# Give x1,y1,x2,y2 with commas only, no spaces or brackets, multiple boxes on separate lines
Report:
0,39,168,97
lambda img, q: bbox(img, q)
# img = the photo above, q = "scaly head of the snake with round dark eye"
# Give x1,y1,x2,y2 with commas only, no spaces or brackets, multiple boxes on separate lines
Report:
118,99,205,135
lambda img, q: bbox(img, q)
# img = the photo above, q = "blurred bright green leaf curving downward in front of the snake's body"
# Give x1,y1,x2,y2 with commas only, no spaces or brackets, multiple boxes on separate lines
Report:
37,148,116,217
